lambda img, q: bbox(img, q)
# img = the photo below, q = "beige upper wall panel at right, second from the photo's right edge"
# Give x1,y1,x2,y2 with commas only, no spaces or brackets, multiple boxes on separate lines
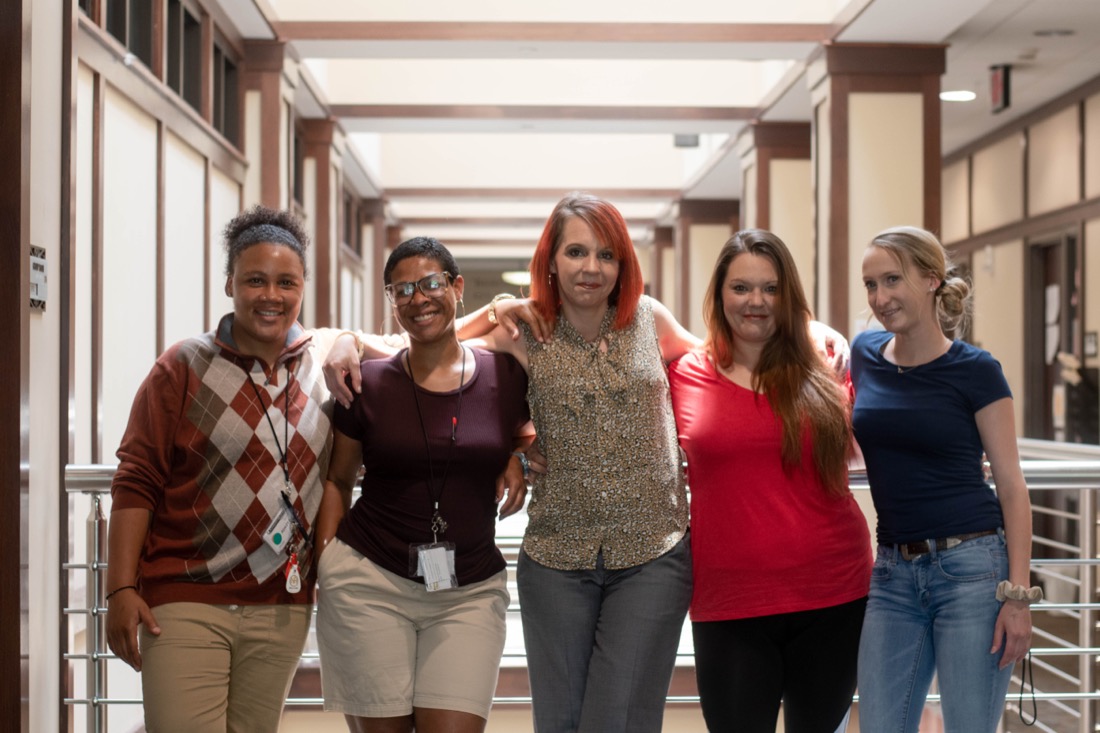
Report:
1027,105,1081,216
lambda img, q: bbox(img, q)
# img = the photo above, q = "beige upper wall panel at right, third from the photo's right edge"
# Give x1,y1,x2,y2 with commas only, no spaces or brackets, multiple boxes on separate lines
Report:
971,134,1024,234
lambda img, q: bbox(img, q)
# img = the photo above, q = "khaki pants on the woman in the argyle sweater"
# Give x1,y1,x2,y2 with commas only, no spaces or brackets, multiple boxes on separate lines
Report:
141,603,312,733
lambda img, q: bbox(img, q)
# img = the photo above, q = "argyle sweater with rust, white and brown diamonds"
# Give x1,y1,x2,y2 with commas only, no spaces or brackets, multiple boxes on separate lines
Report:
111,314,332,606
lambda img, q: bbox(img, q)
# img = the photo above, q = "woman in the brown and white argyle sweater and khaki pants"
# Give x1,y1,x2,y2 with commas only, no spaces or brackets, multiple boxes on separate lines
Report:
107,206,404,733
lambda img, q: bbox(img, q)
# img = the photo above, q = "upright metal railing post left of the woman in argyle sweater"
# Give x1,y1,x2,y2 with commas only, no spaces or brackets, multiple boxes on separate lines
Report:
87,493,107,733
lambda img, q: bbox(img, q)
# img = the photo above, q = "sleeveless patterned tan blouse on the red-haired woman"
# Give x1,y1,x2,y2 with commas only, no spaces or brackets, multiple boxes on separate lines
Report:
524,296,688,570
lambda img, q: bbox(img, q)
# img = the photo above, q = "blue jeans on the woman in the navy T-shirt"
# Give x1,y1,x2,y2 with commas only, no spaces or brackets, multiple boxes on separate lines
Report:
858,533,1012,733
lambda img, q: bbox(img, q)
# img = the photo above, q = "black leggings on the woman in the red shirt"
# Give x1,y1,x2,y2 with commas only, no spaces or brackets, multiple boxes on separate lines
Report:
692,598,867,733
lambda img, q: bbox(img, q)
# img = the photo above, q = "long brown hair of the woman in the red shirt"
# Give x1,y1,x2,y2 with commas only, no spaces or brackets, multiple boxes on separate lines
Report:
703,229,851,495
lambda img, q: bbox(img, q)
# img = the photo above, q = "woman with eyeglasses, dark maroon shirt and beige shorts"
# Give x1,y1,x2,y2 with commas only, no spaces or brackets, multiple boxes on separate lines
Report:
317,237,529,733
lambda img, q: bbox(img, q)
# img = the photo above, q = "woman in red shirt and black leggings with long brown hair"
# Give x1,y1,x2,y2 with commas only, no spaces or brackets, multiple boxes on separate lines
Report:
669,230,871,733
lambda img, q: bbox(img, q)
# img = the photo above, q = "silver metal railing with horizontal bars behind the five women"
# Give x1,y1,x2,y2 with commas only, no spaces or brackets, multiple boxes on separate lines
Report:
64,439,1100,733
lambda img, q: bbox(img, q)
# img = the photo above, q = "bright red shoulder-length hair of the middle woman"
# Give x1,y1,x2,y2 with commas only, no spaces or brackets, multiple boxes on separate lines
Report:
530,192,642,330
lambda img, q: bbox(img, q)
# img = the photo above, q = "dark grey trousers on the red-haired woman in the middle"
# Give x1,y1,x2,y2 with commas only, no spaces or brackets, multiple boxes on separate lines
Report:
517,536,692,733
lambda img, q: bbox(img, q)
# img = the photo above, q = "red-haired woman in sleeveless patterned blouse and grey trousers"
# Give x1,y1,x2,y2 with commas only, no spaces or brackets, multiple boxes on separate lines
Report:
473,194,697,733
